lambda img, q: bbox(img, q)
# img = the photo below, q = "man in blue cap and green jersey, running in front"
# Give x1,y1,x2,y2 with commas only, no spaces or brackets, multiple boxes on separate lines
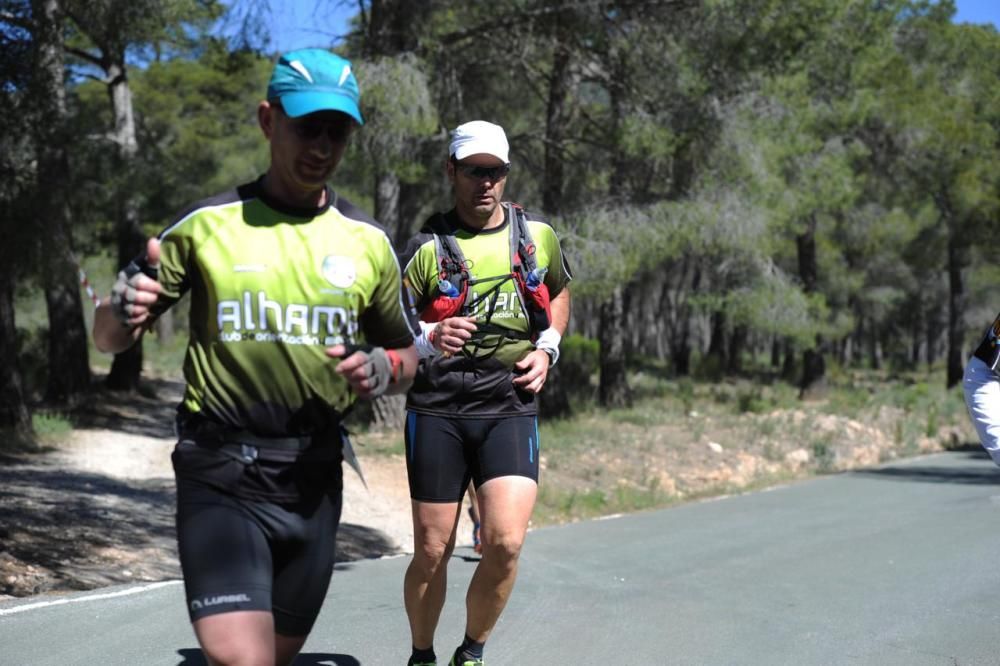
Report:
94,49,419,665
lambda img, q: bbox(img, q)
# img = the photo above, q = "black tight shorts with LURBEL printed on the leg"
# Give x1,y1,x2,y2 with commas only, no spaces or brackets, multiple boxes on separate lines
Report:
173,440,342,636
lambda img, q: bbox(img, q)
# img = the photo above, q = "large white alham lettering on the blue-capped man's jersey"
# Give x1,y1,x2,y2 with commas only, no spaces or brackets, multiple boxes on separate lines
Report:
217,291,358,341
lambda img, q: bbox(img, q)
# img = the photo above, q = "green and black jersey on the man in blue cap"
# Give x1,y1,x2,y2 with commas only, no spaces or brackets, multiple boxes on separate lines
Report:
156,180,416,436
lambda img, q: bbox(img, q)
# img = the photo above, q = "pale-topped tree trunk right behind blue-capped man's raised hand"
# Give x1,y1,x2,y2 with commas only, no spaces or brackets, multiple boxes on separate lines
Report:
105,58,146,391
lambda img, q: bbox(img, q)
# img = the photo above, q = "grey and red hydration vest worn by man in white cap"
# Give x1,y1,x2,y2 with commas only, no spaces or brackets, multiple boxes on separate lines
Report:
420,202,552,340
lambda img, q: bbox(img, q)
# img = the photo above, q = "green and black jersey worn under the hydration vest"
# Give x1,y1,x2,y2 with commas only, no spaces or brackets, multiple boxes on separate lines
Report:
401,207,572,418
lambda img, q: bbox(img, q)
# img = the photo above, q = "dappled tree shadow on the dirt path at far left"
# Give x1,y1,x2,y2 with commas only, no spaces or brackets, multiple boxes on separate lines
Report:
0,462,179,596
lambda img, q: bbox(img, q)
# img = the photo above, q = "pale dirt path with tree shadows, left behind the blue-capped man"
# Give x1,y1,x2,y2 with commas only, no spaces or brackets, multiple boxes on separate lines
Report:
0,381,446,599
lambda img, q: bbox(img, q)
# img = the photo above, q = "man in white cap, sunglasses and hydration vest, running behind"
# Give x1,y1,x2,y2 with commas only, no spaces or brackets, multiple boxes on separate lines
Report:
402,120,570,666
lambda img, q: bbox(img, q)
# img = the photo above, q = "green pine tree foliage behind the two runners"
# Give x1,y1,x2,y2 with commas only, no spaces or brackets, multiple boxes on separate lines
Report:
7,0,1000,404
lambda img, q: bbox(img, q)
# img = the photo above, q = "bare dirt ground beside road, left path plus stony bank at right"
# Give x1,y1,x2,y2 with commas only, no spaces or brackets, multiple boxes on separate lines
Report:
0,380,969,599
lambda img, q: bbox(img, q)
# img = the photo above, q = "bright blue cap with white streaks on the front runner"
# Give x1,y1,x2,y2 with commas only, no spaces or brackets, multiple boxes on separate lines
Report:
267,49,365,125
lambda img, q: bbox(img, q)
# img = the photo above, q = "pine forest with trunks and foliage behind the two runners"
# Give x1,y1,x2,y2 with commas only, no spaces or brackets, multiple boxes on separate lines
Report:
0,0,1000,488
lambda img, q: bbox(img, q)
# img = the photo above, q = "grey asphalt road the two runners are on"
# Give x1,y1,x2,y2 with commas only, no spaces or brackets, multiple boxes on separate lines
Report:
0,451,1000,666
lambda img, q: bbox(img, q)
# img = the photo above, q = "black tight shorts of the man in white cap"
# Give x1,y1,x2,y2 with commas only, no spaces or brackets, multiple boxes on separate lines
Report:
405,411,539,502
